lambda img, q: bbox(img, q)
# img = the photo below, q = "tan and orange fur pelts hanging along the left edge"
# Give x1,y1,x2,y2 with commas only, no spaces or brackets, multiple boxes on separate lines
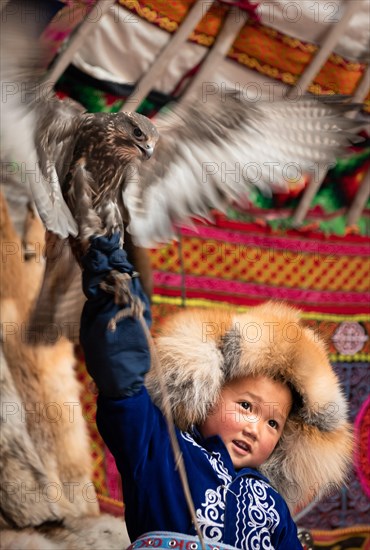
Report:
0,195,128,550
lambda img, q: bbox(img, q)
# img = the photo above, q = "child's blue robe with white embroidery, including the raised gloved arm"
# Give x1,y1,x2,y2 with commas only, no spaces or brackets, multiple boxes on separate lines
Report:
81,235,302,550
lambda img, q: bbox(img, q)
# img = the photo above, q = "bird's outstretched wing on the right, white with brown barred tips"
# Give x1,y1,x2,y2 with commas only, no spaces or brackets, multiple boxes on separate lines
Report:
123,93,359,246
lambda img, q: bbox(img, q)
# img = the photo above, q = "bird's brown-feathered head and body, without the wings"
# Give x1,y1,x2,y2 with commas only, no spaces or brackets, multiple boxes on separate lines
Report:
57,113,158,261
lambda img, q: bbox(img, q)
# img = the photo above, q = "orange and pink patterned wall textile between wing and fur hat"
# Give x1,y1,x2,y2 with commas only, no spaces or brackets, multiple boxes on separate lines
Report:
147,214,370,315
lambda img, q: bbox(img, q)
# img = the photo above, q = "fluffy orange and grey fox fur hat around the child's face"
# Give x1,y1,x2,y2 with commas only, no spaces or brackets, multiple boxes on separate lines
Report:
146,302,352,509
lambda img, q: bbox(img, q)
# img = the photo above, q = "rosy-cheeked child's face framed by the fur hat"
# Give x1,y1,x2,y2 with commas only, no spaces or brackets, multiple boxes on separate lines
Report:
200,376,292,470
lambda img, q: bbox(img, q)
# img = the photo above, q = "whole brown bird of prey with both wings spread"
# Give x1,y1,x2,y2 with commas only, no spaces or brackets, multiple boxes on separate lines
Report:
1,7,358,340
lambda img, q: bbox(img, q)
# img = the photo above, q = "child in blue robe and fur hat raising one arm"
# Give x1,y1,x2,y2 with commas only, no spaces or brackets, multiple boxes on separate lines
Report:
81,235,351,550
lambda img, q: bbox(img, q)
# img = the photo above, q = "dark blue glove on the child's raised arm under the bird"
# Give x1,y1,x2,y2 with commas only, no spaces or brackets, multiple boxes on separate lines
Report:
80,233,151,399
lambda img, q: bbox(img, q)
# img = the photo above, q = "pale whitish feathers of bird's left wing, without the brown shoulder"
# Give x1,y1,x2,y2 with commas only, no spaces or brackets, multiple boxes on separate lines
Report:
0,8,77,237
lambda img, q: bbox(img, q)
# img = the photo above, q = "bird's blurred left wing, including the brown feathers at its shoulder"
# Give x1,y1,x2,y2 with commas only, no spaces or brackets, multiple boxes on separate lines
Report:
0,6,81,237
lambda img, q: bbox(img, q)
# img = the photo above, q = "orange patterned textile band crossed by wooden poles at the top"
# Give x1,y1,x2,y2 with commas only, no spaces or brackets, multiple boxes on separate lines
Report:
118,0,370,112
